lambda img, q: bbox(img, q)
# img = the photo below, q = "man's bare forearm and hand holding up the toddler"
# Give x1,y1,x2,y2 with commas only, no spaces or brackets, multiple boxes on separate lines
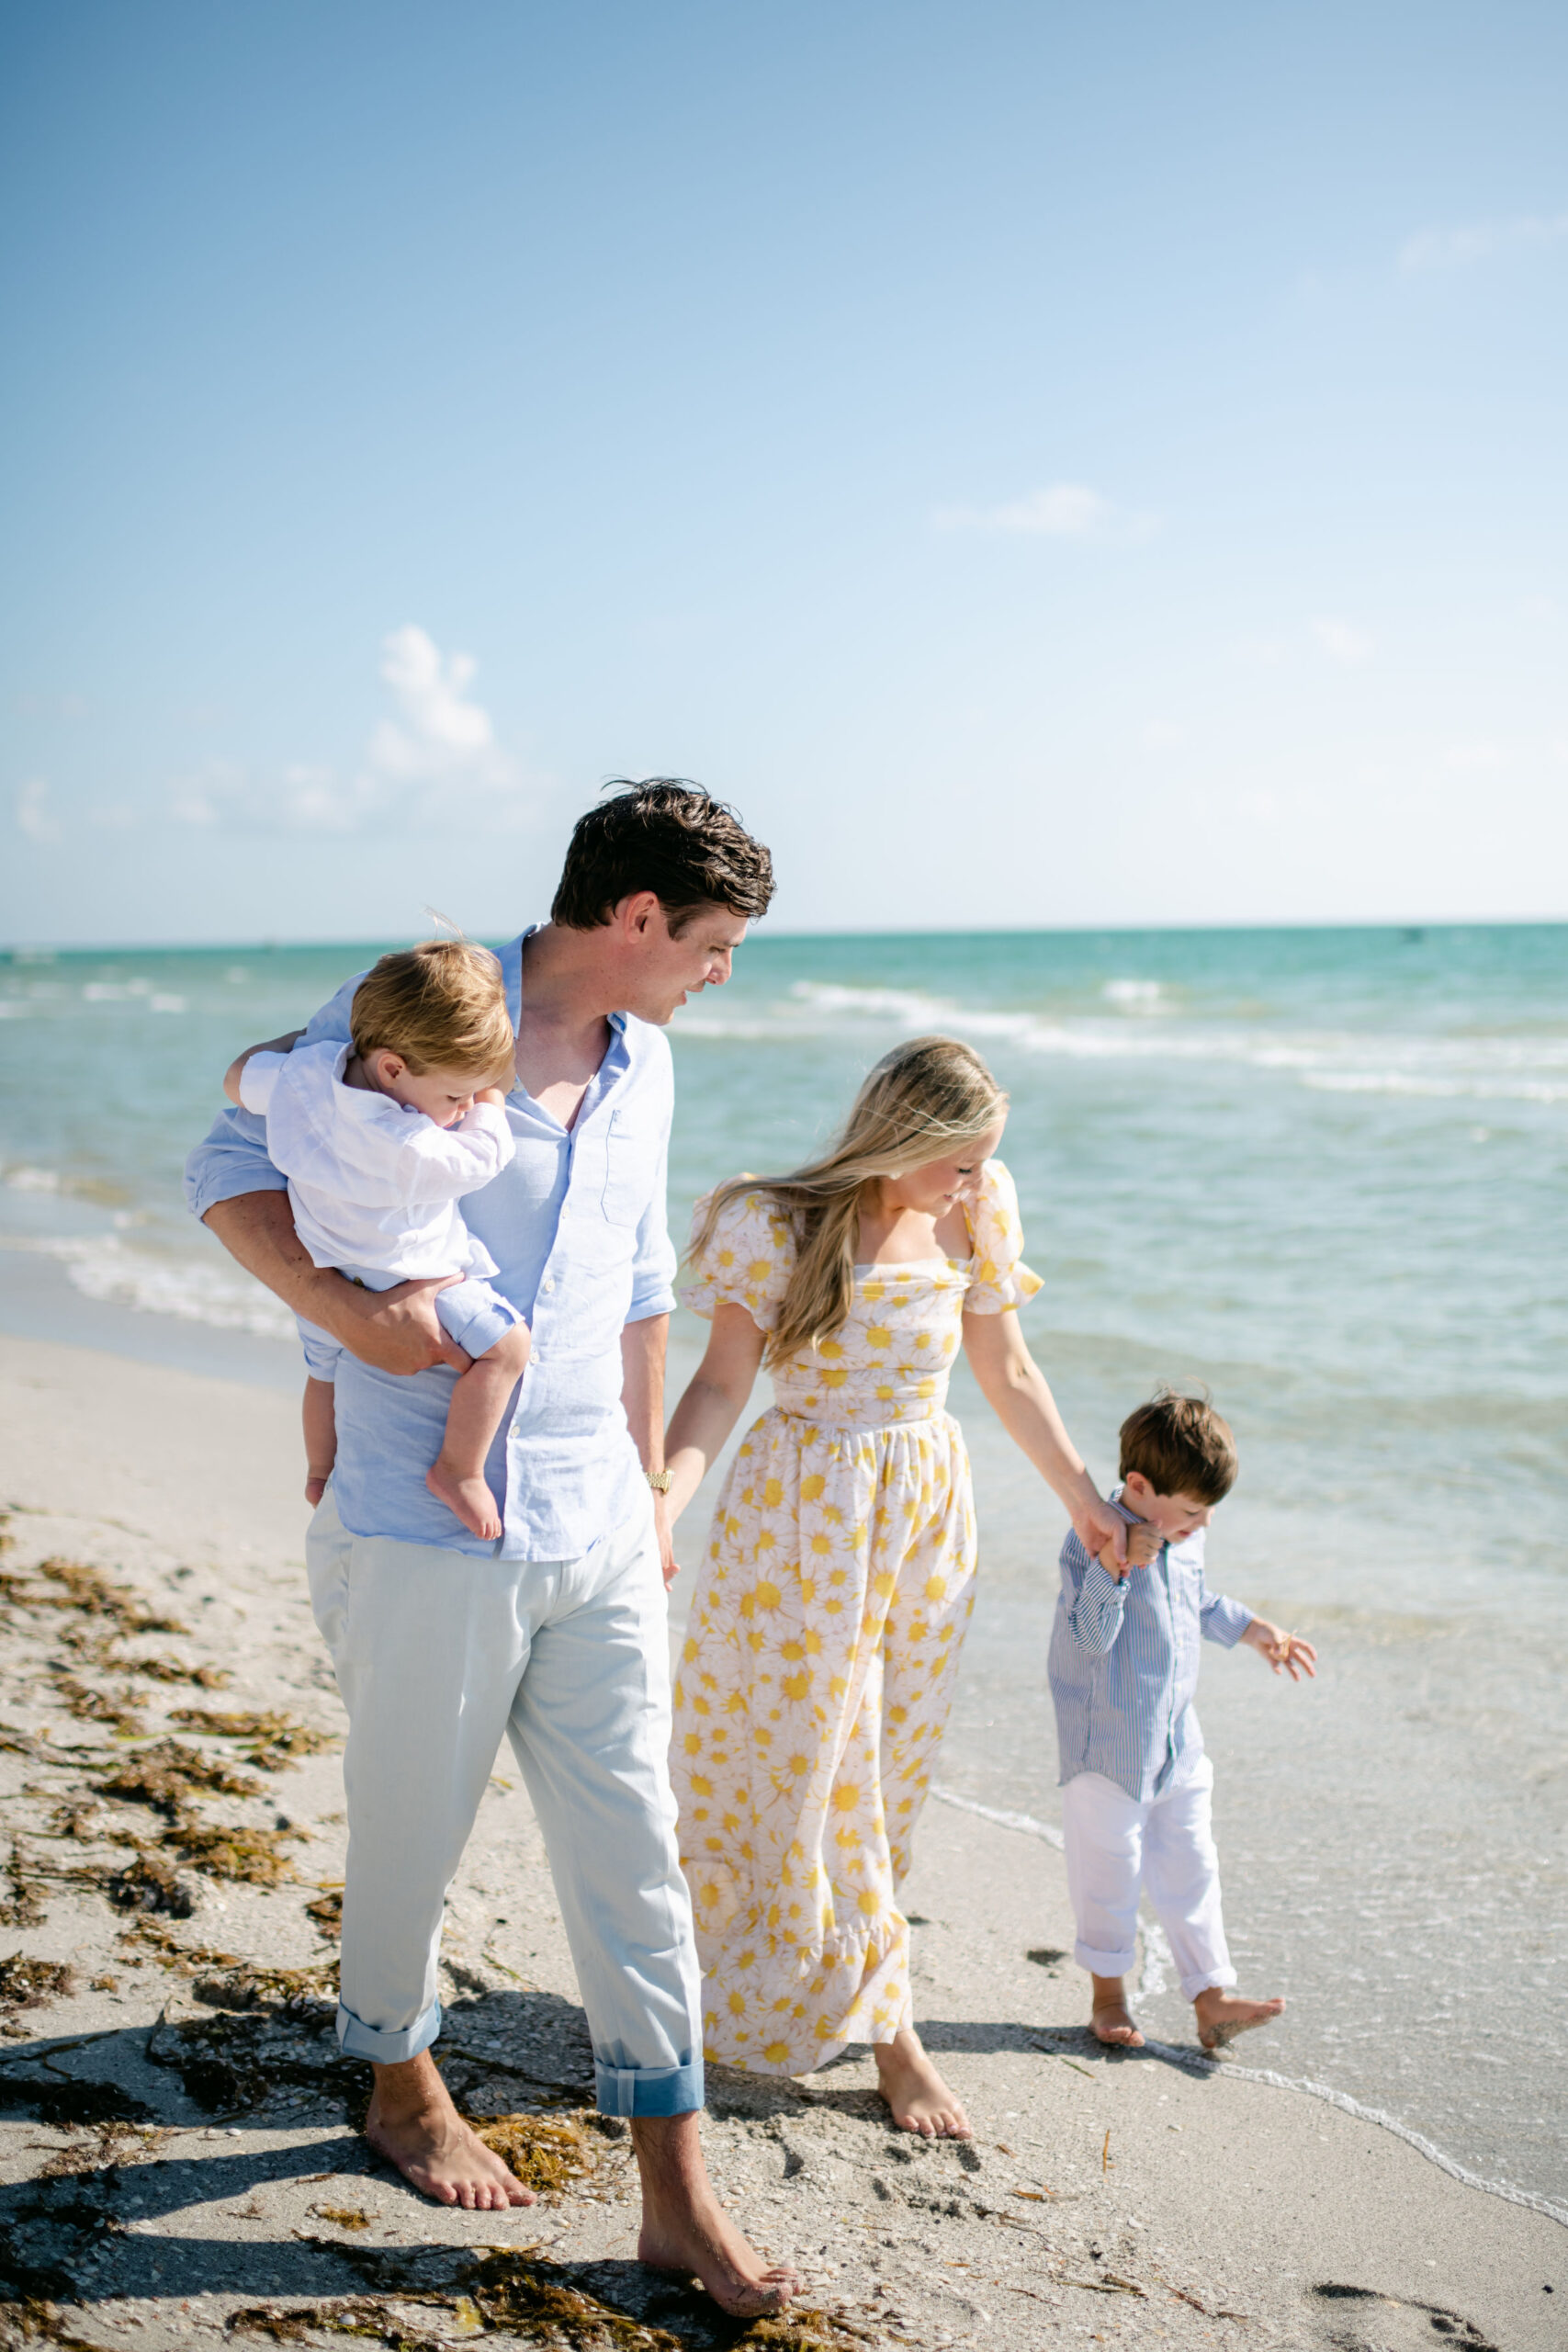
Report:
205,1193,470,1374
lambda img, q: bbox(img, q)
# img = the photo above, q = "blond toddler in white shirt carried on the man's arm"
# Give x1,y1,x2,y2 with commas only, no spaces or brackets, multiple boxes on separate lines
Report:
223,938,529,1541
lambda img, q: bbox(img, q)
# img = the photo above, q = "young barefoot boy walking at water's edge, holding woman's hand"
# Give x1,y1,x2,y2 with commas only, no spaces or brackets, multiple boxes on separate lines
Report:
1051,1390,1316,2051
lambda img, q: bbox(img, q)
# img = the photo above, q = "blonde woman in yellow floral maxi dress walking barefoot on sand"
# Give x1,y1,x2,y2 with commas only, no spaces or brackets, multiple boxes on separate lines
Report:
665,1037,1123,2138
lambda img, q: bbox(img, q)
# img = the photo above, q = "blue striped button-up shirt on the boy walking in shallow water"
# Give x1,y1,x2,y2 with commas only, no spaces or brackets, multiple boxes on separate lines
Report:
1048,1488,1253,1804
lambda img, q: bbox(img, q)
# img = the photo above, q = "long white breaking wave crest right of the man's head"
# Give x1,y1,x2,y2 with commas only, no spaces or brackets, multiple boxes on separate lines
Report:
680,981,1568,1103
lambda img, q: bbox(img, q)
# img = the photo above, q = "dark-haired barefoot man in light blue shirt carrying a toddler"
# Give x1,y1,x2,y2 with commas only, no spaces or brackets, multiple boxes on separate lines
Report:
186,778,797,2314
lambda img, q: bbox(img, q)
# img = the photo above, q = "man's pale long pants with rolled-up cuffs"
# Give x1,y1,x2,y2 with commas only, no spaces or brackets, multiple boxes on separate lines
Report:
306,1487,703,2114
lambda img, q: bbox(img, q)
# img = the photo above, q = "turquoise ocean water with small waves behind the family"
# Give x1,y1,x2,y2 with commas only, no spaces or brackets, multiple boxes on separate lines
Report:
0,927,1568,2209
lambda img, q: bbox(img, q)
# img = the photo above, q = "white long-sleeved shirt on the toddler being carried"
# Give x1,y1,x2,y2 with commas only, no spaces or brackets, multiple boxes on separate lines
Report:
240,1040,517,1289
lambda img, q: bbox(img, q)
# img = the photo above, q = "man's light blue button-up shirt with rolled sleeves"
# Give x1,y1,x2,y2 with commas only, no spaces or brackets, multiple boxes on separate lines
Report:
186,932,674,1559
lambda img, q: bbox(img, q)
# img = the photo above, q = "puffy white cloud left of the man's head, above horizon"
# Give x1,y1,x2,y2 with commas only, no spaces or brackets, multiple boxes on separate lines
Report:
169,623,531,835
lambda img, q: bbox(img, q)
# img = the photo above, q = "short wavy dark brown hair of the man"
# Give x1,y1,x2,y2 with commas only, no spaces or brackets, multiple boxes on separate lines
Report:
550,776,773,938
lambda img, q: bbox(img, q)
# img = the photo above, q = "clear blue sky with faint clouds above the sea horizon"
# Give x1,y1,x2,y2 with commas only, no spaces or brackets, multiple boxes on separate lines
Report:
0,0,1568,944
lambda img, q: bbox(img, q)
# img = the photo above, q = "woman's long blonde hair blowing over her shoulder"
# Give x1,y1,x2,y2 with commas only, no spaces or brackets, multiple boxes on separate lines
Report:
691,1037,1006,1364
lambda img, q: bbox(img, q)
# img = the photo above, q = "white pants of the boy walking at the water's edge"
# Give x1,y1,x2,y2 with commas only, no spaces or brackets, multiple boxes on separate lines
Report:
1063,1757,1236,2002
